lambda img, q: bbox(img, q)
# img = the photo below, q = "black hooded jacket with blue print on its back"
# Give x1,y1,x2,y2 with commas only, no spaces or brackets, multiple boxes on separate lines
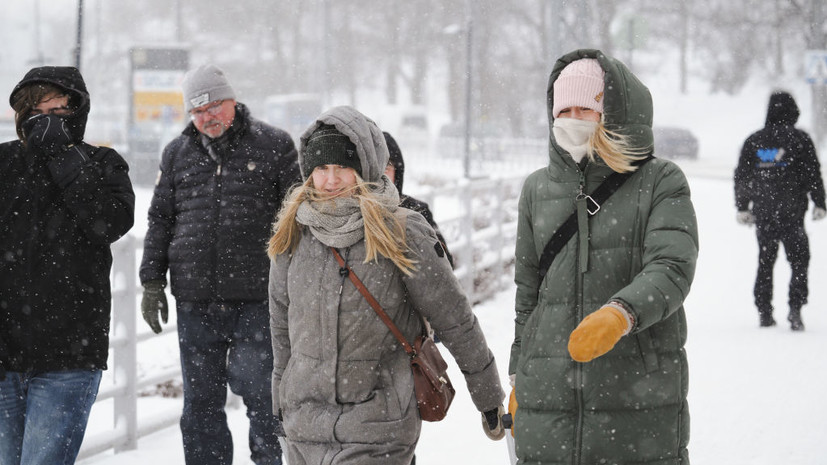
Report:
735,92,825,225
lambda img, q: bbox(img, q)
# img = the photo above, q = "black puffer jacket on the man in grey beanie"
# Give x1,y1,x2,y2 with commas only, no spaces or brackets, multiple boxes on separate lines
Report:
140,103,300,302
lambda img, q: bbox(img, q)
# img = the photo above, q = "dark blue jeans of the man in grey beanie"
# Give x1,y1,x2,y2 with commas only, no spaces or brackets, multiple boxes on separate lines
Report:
178,301,281,465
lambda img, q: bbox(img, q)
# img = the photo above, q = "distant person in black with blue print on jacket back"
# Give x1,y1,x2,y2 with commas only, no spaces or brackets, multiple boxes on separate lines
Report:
735,92,827,331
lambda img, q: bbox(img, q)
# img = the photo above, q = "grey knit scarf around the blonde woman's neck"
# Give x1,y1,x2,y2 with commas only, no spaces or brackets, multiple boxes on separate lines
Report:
296,176,399,248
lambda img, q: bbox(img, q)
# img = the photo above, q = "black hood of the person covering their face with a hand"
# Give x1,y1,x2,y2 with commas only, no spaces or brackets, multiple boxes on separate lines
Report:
9,66,90,141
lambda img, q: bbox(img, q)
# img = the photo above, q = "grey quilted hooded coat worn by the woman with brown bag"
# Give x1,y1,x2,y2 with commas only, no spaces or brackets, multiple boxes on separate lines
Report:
270,107,504,465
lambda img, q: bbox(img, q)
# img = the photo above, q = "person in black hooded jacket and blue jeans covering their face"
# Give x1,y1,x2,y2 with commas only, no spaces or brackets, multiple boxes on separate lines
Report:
0,66,135,464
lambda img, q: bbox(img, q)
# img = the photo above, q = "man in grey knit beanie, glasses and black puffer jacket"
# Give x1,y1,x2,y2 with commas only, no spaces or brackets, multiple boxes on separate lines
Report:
140,65,299,465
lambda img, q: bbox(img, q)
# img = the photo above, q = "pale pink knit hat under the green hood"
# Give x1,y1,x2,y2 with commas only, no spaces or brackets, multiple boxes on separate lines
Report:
551,58,606,118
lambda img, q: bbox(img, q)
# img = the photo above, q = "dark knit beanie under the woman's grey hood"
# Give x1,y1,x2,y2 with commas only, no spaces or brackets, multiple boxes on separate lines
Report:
301,124,362,177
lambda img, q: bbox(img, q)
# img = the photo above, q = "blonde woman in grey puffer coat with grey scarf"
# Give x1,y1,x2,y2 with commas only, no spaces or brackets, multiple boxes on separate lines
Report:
269,107,504,465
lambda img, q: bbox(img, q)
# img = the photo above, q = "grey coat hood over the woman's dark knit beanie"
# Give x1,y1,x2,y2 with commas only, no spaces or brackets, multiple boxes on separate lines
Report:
299,106,389,182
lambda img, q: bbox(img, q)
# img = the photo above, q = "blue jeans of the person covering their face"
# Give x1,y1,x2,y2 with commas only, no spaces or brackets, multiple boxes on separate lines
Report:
0,370,101,465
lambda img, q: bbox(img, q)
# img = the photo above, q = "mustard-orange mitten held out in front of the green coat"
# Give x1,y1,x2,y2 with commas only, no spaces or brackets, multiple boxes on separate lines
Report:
569,304,632,362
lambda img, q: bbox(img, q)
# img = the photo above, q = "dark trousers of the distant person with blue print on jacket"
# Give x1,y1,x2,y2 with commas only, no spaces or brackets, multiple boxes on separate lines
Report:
753,219,810,312
